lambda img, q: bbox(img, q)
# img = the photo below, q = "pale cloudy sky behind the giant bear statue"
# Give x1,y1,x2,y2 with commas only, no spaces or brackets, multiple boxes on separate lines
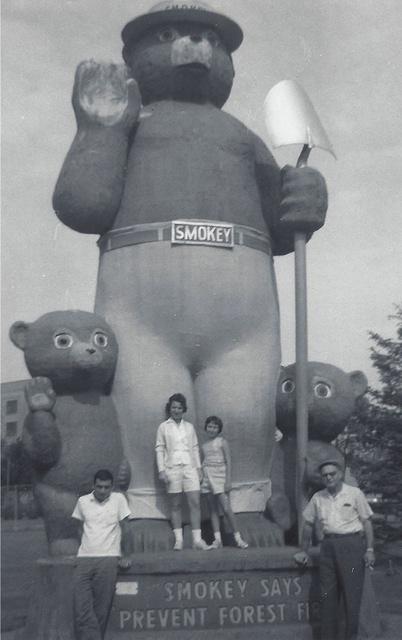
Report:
1,0,402,387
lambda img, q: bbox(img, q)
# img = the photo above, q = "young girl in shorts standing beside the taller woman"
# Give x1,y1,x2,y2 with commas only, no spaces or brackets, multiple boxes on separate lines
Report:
201,416,248,549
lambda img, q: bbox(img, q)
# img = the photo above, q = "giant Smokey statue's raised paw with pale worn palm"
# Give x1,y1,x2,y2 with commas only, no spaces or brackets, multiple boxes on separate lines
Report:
73,60,141,130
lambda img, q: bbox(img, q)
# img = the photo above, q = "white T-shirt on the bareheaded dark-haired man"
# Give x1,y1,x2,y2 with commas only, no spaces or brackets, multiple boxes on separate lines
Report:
72,492,130,556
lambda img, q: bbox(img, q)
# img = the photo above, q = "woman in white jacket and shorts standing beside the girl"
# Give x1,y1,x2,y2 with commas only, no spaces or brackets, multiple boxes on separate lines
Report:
155,393,210,551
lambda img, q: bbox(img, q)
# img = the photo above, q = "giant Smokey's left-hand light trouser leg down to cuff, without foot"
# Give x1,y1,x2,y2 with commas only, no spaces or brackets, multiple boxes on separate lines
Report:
112,336,194,490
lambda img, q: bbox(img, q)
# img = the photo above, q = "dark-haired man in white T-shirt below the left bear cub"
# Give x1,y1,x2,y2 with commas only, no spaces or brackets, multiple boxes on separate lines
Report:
72,469,131,640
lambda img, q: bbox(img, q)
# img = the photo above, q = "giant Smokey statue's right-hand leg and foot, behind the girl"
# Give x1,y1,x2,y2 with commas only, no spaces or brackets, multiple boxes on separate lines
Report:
195,328,283,546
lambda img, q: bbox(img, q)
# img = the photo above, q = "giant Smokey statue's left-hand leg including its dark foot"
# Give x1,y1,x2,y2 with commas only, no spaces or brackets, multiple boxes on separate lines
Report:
105,330,195,553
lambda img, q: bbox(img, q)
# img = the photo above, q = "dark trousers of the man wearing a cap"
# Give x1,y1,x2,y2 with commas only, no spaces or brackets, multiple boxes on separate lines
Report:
320,534,366,640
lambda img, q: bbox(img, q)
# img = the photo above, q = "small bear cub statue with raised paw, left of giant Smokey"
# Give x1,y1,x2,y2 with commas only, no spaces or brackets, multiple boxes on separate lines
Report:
10,311,130,556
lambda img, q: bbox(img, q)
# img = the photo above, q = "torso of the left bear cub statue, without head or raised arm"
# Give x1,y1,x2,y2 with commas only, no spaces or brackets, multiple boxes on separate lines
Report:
38,394,123,494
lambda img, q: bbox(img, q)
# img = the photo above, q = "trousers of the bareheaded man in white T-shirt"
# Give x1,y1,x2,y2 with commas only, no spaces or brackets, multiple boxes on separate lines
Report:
74,556,119,640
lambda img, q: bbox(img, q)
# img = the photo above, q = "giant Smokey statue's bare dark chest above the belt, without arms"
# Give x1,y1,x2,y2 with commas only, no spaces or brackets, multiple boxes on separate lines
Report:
113,101,276,231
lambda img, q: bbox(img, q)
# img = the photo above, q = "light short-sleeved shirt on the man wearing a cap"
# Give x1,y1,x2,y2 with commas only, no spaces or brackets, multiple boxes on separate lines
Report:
303,483,373,534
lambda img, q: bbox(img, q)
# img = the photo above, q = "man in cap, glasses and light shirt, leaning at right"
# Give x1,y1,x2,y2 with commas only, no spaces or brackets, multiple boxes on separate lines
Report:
294,460,374,640
